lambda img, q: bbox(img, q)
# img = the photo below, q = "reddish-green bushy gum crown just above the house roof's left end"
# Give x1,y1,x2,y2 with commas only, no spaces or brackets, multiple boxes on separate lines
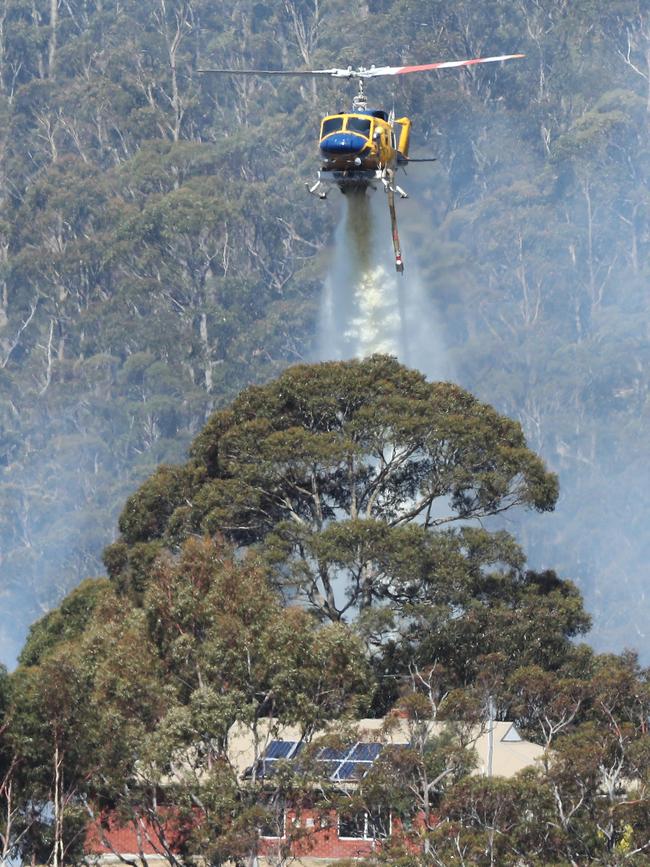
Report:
144,540,370,724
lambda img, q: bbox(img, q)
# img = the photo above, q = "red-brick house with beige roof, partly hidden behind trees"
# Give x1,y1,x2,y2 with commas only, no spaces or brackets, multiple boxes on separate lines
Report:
88,717,544,867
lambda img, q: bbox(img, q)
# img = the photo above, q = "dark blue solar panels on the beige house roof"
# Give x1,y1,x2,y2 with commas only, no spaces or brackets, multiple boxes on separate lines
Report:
246,741,383,783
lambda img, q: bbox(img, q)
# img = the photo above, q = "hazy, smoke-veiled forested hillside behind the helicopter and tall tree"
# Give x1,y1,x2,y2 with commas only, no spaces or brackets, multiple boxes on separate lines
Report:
0,0,650,659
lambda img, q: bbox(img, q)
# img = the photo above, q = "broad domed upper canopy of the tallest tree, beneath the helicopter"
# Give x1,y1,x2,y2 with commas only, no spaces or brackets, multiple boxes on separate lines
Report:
106,356,558,620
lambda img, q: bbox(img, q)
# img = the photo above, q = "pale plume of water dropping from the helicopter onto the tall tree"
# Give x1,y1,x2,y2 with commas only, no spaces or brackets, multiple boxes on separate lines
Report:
318,191,451,379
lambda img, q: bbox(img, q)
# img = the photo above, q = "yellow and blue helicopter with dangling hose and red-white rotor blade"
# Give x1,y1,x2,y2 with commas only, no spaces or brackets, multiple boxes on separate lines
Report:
198,54,525,273
